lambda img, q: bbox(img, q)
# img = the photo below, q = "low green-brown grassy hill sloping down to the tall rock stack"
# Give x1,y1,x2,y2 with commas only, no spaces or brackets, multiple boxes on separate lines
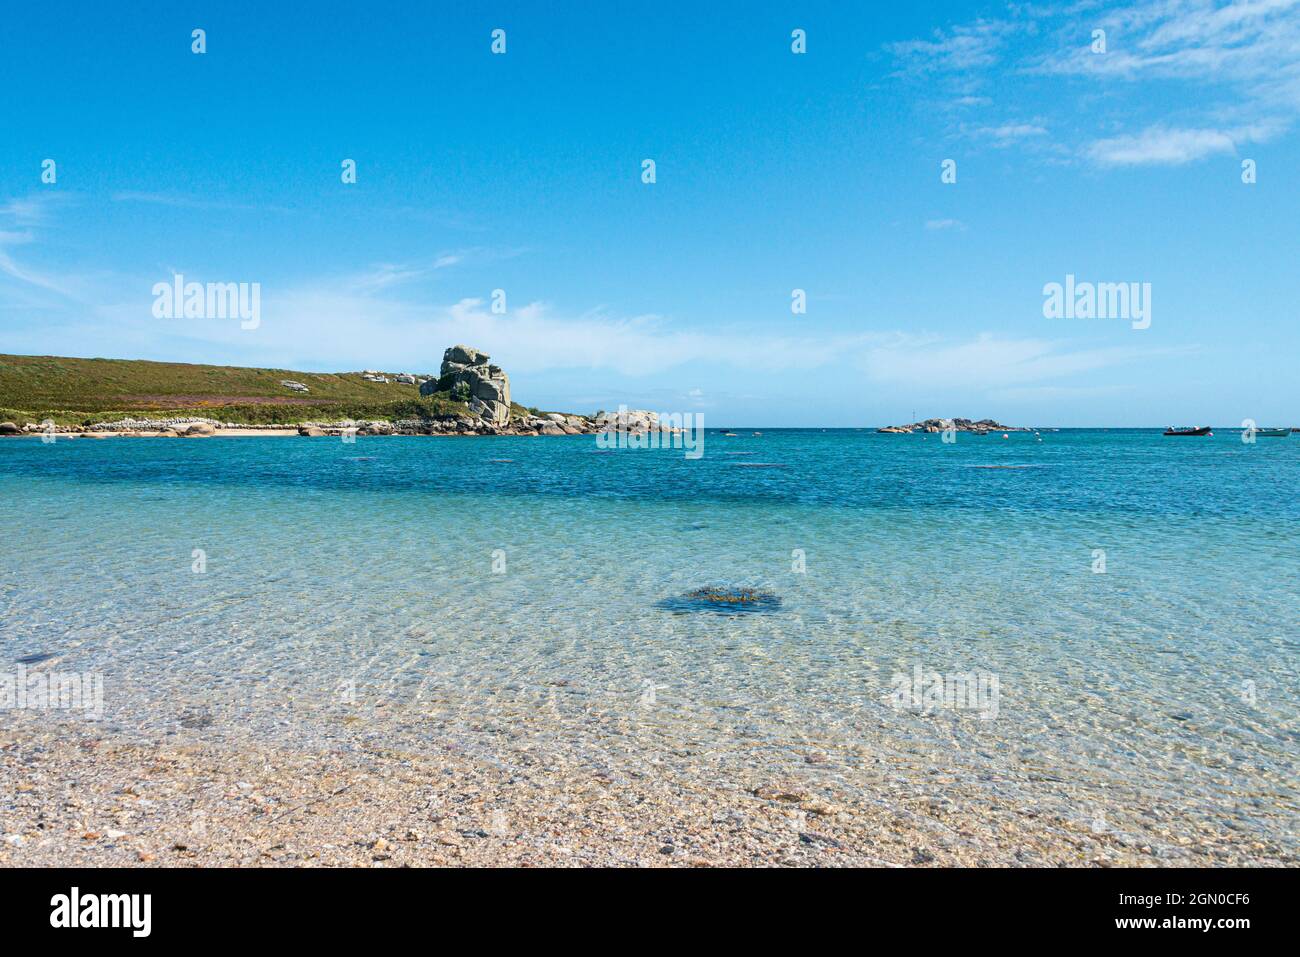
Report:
0,355,509,424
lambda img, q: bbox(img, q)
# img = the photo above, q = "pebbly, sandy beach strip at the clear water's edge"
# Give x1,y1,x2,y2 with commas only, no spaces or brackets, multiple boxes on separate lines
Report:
0,727,1290,867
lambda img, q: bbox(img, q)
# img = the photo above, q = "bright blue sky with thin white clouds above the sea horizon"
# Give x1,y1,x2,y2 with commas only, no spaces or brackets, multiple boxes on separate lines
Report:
0,0,1300,426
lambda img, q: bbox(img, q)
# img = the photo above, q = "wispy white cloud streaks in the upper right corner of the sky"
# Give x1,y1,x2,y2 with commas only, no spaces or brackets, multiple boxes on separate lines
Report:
887,0,1300,168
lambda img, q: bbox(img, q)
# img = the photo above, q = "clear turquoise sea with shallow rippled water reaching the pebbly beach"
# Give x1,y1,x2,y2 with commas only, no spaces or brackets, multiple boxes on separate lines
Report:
0,429,1300,853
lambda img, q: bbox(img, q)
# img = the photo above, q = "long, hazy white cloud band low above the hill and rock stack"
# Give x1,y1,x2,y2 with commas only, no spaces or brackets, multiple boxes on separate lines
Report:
78,273,1185,402
